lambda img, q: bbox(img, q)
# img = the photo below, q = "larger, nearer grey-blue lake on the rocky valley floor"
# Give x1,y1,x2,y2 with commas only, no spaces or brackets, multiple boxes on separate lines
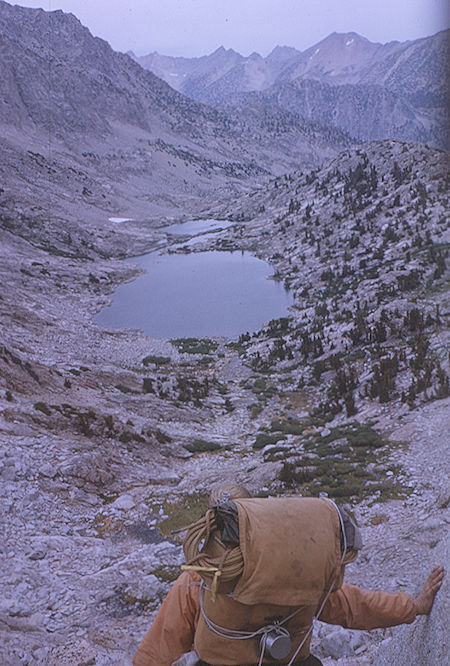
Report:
96,251,293,339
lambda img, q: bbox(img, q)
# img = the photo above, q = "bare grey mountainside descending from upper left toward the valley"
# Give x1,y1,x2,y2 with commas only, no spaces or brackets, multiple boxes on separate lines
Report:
0,1,354,223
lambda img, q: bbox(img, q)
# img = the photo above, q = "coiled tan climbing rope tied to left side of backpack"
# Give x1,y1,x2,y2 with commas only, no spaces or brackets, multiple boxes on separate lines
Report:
181,509,244,601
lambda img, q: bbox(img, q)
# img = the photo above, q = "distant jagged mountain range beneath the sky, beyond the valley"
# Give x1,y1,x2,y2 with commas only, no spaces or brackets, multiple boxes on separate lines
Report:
131,30,449,147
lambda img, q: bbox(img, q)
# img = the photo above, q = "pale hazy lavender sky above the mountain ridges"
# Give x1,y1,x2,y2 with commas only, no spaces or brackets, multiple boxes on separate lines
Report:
8,0,450,56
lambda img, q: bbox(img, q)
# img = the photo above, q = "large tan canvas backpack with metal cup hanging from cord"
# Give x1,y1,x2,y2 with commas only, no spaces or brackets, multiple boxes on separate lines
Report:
185,497,344,666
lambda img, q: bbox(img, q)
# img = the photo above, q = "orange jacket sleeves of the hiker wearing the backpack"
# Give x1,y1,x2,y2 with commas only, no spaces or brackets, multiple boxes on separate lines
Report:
133,571,417,666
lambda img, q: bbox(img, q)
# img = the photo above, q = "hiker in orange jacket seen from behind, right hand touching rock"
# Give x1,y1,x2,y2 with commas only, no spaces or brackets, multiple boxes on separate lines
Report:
133,484,444,666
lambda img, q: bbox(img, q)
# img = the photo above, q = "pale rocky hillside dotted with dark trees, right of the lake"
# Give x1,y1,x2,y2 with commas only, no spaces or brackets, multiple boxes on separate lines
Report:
194,142,449,440
